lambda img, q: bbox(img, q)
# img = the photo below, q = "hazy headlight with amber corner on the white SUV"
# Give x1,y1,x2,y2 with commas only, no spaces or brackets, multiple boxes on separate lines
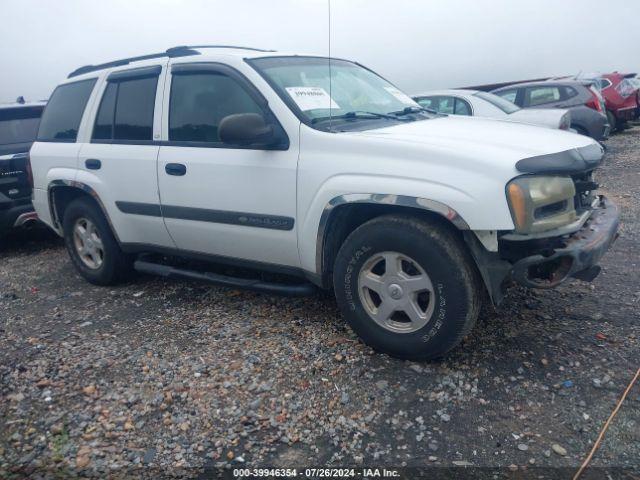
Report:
507,176,576,233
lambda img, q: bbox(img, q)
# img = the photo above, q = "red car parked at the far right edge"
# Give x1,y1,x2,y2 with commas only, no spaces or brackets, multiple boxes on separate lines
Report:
600,72,640,130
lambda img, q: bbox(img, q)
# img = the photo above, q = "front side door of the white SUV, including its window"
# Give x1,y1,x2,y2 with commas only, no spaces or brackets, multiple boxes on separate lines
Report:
158,64,299,266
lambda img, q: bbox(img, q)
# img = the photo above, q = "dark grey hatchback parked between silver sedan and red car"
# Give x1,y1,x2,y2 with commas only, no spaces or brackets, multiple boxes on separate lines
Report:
492,80,609,140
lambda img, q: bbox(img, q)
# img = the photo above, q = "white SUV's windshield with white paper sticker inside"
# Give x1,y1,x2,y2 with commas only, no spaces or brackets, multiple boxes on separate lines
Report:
249,57,431,128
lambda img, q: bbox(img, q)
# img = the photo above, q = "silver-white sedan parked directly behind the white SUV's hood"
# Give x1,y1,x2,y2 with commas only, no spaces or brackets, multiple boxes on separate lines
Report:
413,89,571,130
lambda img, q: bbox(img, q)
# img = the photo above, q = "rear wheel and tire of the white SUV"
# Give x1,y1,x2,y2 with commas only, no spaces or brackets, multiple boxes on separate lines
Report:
62,198,132,285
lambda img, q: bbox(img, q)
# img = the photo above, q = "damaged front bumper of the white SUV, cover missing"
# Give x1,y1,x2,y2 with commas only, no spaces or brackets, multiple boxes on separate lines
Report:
465,196,619,304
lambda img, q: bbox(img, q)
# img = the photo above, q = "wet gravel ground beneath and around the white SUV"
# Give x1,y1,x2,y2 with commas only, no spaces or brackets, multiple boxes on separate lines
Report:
0,127,640,478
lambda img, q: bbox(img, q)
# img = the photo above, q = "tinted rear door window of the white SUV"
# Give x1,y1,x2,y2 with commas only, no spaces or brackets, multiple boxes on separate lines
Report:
92,75,158,143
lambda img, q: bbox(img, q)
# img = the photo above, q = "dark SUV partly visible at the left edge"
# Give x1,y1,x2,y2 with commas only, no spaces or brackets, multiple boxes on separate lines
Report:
0,97,45,237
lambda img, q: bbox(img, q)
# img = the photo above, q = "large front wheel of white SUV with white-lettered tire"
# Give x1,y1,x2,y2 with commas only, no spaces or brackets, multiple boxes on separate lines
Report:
333,215,481,360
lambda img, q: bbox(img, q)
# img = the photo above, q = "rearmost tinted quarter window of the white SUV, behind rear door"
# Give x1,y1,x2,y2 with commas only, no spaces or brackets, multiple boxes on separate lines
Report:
37,78,96,142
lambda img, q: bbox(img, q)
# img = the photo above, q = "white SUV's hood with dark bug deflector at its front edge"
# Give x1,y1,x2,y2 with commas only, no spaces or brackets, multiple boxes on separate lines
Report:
336,115,603,179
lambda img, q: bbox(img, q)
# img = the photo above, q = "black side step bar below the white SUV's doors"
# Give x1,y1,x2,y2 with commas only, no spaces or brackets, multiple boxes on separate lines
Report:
133,260,316,297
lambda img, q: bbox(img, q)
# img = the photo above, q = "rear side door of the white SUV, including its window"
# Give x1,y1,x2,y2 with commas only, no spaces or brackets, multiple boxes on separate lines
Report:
77,61,175,248
